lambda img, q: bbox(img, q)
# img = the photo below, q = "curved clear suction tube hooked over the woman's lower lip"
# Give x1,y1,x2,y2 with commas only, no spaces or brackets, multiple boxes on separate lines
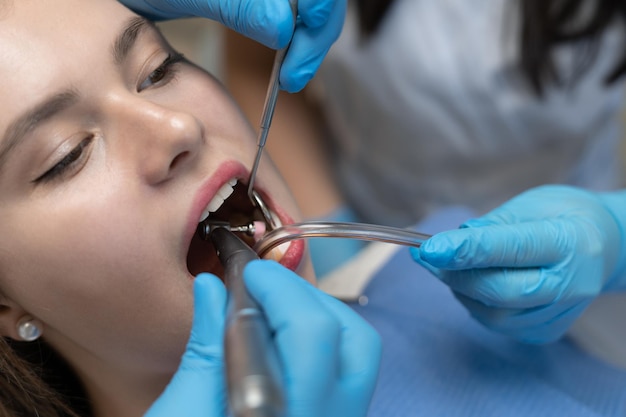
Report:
254,222,430,258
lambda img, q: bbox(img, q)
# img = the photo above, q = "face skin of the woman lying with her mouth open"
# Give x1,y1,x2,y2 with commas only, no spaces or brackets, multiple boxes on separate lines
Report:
0,0,314,416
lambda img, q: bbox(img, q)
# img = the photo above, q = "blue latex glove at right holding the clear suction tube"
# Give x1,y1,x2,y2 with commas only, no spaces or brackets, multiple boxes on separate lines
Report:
411,186,626,343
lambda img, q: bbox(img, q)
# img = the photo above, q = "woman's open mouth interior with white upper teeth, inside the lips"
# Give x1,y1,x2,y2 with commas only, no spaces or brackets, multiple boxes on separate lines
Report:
187,180,276,277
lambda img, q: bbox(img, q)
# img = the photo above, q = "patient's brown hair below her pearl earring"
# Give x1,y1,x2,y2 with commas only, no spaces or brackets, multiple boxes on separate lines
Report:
0,338,90,417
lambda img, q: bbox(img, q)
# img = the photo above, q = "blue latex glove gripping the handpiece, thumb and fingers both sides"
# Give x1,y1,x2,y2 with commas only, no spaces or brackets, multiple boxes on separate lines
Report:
145,261,381,417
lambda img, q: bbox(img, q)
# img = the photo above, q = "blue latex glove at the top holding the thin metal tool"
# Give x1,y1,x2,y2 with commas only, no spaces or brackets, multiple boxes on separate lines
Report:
120,0,346,92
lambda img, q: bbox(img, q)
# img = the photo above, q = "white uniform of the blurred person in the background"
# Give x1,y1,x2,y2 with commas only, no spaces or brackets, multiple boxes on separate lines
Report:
314,0,624,226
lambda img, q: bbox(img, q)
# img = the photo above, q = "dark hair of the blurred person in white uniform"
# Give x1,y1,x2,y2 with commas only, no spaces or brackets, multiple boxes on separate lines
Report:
356,0,626,95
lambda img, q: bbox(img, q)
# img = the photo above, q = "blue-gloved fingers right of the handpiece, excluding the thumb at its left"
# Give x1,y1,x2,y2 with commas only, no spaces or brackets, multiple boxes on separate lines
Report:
244,260,381,417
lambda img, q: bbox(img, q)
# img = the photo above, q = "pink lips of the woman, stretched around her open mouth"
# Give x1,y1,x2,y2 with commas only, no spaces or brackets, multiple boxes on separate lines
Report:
184,161,305,271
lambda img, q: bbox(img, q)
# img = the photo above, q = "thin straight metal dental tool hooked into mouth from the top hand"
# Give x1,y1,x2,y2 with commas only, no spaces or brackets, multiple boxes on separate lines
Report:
248,0,298,230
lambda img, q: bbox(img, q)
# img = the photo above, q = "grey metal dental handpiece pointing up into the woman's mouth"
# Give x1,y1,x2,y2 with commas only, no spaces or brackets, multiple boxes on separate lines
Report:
210,227,285,417
